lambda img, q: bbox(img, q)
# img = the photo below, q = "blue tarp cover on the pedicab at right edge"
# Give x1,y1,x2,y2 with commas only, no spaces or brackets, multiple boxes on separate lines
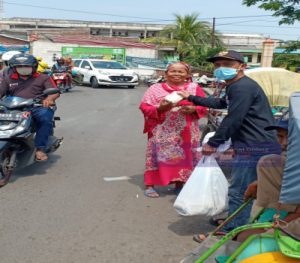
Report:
280,92,300,204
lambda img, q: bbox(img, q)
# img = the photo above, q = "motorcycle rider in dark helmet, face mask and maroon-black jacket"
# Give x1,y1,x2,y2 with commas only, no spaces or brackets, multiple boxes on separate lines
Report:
0,54,60,161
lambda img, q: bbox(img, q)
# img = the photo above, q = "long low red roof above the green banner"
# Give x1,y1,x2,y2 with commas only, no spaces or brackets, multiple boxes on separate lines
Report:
51,36,155,49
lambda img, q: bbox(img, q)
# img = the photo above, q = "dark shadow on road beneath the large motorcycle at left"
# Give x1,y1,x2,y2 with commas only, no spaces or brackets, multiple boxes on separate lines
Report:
10,154,61,183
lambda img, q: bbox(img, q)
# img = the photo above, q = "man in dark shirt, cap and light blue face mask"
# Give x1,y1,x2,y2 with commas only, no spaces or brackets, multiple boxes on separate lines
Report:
180,50,280,239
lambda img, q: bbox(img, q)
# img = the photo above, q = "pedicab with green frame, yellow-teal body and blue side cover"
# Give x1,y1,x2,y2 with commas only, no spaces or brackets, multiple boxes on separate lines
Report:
182,92,300,263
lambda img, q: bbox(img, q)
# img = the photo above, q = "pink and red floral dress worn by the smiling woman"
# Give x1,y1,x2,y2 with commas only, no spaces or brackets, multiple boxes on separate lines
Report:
140,83,206,188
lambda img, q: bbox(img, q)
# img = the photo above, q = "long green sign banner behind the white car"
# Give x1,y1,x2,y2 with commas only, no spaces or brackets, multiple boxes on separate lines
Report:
61,47,126,64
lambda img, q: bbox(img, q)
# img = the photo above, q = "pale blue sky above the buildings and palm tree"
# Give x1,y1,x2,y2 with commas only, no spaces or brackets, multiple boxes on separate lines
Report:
0,0,300,40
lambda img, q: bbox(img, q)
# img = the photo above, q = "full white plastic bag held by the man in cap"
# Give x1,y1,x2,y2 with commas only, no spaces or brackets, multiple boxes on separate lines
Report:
174,155,228,216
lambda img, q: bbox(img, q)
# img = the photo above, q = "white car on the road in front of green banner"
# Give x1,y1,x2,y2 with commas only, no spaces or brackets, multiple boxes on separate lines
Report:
73,59,139,88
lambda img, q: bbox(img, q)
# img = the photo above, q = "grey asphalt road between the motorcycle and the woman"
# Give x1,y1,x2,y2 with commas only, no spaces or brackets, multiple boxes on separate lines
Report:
0,84,211,263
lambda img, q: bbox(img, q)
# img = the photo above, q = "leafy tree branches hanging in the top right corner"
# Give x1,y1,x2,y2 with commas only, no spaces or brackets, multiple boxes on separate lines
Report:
243,0,300,25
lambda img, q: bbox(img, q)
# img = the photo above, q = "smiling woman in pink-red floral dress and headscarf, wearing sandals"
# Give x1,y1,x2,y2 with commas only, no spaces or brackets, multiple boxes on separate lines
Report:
140,62,206,197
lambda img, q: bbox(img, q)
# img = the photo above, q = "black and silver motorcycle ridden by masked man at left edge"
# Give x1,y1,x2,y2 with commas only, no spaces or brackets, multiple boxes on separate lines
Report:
0,88,63,187
